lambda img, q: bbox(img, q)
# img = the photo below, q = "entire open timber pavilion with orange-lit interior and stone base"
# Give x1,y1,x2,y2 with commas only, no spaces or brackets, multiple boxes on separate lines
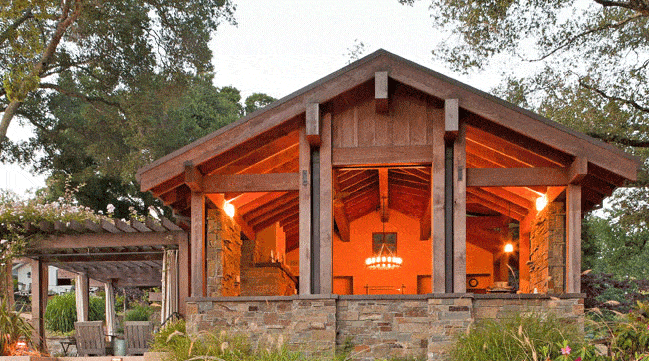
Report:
138,50,639,358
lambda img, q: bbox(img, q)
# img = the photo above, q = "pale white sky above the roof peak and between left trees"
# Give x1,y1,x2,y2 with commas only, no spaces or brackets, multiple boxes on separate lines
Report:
0,0,498,195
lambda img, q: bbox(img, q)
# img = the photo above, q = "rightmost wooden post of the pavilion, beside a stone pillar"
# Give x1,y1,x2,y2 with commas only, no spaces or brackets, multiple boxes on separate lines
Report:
566,184,581,293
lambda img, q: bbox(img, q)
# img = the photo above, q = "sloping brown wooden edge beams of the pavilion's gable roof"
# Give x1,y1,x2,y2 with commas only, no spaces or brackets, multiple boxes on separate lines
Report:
136,49,640,195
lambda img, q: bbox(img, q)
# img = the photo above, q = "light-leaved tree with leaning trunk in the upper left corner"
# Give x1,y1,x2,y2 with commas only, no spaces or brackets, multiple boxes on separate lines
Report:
0,0,235,143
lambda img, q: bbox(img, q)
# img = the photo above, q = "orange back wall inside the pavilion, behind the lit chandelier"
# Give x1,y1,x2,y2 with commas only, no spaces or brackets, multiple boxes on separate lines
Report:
333,209,431,294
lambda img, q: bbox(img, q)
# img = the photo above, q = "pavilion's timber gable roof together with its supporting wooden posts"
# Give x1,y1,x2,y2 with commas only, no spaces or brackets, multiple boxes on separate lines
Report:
138,50,639,297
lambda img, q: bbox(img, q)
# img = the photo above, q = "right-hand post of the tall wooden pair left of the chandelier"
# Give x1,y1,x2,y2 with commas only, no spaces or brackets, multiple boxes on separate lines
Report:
320,113,333,294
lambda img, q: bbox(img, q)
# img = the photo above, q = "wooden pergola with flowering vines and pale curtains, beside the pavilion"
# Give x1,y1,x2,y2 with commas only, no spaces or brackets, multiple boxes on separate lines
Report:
15,218,189,347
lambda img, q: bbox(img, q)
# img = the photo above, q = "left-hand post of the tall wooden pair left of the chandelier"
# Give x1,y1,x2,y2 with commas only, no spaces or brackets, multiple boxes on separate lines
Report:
298,129,312,295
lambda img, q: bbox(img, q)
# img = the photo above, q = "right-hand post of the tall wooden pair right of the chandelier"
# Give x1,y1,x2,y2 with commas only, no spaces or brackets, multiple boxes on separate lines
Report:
453,123,466,293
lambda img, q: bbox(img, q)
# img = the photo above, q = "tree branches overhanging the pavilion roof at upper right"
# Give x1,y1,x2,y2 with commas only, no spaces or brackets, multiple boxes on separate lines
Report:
400,0,649,163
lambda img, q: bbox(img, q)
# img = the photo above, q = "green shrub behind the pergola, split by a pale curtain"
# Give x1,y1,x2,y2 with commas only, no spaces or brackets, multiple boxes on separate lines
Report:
44,292,105,333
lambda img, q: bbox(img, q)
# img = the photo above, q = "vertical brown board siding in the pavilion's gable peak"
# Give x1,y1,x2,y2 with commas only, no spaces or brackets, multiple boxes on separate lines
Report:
332,82,444,148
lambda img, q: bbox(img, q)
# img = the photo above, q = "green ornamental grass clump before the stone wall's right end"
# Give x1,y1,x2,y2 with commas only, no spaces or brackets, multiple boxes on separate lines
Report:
451,314,593,361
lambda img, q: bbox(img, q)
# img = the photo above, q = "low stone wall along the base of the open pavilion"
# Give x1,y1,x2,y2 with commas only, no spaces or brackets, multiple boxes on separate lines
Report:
187,294,584,360
